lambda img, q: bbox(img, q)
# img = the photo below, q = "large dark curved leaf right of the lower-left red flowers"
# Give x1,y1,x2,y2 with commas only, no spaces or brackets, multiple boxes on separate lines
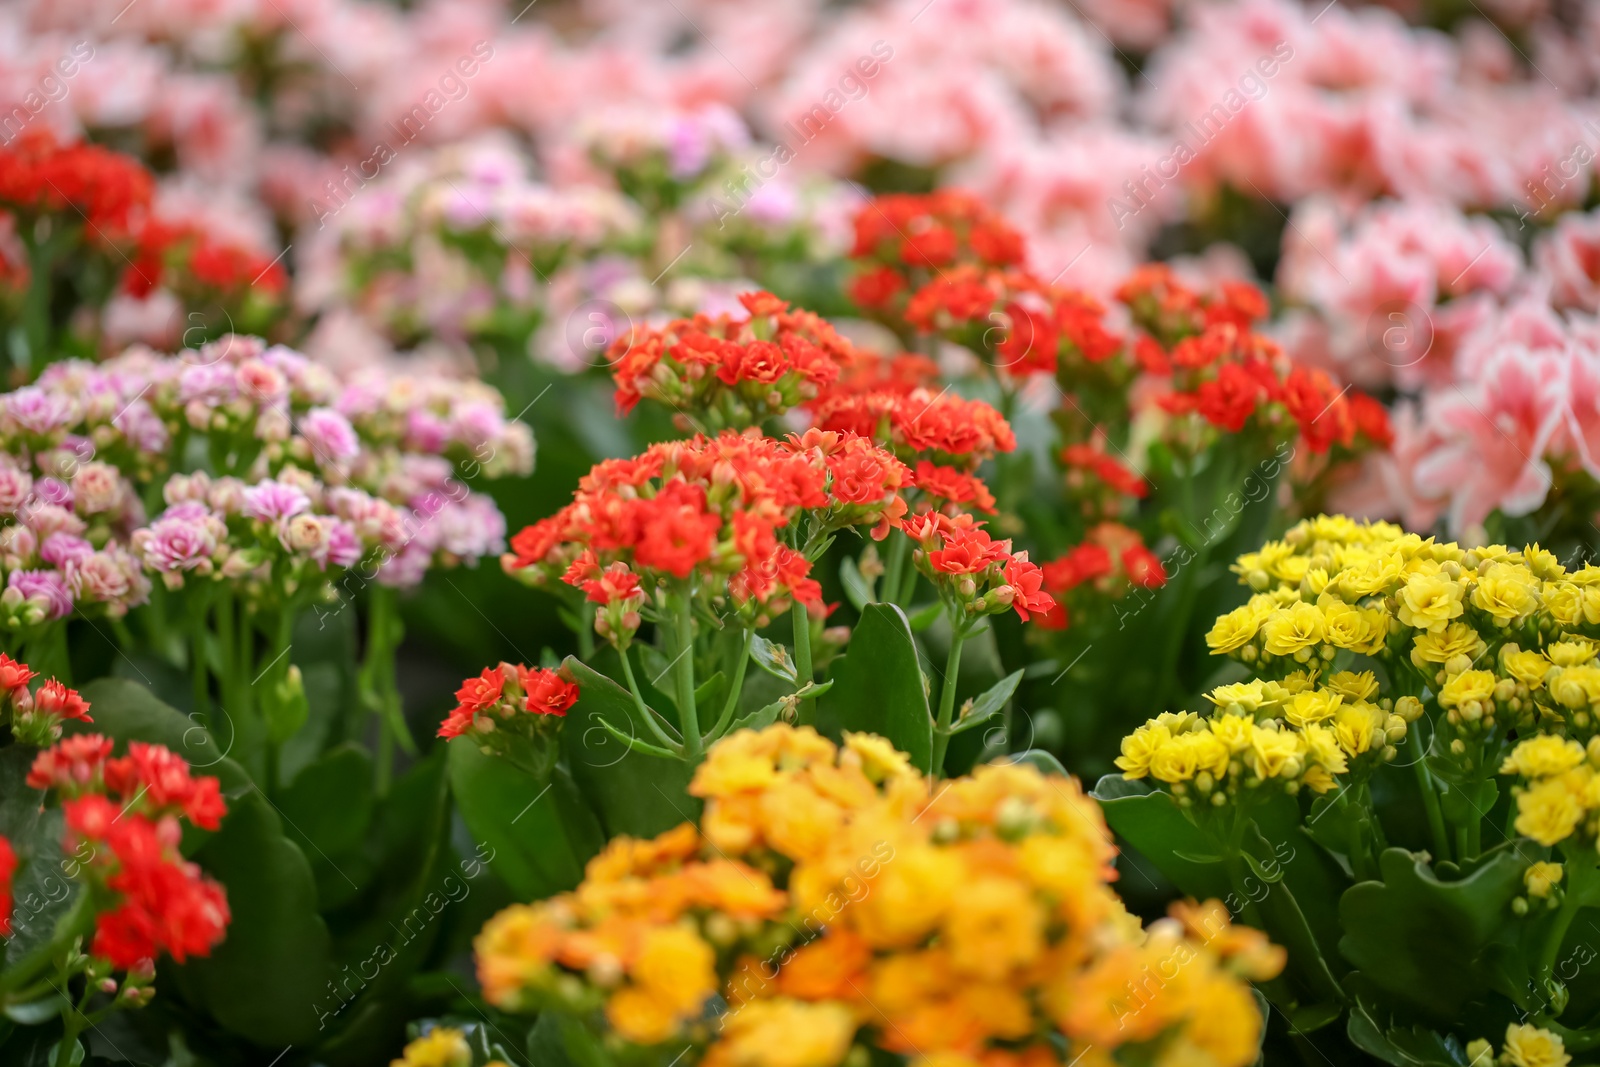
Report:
173,789,331,1048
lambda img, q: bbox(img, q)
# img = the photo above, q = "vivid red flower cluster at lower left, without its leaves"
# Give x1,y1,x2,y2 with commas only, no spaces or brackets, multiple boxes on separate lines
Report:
27,734,229,969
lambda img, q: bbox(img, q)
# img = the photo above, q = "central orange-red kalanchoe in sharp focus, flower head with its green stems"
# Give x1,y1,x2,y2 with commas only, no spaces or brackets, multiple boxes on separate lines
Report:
506,430,912,761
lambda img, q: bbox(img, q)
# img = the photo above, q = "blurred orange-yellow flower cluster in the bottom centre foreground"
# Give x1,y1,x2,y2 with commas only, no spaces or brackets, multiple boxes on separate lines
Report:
477,725,1283,1067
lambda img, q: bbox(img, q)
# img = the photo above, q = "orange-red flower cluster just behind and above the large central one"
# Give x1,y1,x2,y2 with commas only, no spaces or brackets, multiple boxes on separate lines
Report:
608,293,854,429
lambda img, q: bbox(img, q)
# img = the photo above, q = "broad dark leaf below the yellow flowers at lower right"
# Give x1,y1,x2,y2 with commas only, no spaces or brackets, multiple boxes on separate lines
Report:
1339,848,1525,1022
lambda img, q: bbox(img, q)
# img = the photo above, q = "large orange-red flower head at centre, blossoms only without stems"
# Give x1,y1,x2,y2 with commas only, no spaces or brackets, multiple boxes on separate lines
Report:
504,430,912,646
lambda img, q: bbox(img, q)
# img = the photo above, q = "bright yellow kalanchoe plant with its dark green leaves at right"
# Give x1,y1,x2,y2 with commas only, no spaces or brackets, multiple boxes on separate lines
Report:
1096,517,1600,1064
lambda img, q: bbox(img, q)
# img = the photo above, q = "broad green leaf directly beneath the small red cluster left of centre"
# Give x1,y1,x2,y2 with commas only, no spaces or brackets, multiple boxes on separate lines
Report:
450,737,605,901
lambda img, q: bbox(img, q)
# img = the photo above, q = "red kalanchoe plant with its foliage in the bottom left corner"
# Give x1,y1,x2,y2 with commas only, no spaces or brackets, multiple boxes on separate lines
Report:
0,656,229,1064
